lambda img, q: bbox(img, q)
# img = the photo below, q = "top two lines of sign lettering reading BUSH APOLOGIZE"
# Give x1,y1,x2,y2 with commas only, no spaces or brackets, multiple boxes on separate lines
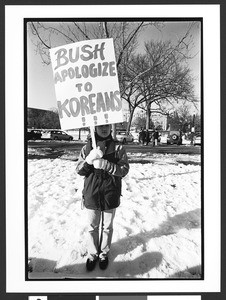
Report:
54,42,116,84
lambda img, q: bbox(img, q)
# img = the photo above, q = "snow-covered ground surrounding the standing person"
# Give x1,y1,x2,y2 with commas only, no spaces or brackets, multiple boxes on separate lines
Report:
28,149,202,279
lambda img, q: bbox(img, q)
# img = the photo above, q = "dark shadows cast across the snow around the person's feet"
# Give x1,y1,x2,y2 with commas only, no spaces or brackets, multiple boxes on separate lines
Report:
29,209,201,279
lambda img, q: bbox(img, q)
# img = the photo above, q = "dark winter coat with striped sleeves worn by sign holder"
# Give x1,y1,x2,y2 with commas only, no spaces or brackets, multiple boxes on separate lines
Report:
76,137,129,211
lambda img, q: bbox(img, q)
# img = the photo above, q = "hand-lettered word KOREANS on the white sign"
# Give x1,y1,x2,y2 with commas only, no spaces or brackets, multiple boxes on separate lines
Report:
57,91,122,119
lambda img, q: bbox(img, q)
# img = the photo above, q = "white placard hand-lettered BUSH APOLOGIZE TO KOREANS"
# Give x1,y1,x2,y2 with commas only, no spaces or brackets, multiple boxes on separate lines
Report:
50,39,123,129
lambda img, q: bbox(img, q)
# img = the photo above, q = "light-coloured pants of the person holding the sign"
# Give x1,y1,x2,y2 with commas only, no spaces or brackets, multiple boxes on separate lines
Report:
87,208,116,257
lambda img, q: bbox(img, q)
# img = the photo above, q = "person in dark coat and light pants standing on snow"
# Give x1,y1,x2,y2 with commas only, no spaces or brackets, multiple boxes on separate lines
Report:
76,124,129,271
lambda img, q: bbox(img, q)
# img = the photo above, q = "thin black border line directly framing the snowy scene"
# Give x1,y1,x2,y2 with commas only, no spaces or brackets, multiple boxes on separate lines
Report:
24,18,205,282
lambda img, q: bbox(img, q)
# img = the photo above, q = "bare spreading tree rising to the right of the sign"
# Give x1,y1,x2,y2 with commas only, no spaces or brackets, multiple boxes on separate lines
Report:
121,24,198,130
